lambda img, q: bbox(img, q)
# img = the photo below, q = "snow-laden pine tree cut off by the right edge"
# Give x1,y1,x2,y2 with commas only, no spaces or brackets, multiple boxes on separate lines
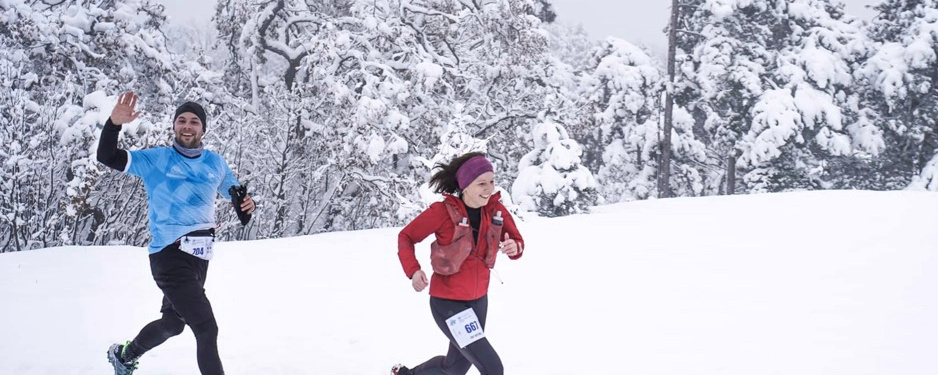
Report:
854,0,938,191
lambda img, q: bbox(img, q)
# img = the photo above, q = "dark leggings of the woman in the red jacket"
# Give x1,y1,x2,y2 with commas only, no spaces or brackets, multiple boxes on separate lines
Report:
411,296,504,375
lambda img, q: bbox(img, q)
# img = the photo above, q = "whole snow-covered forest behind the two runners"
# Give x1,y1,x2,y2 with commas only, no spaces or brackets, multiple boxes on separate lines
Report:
0,0,938,252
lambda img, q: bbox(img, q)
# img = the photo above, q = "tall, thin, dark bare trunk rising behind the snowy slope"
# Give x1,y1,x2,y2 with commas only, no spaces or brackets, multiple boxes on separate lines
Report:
658,0,680,198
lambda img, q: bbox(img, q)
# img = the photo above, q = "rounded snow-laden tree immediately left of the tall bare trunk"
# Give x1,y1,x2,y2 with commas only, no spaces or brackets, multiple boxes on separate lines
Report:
572,37,663,202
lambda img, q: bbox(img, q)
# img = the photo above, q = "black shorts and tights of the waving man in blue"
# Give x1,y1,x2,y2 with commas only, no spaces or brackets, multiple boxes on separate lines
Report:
130,244,225,375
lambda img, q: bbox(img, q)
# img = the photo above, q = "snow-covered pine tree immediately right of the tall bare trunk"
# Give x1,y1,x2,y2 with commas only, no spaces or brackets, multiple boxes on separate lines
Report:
675,0,774,195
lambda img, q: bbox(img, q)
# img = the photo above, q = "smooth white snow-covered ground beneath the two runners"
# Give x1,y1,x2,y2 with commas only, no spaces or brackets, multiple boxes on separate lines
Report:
0,191,938,375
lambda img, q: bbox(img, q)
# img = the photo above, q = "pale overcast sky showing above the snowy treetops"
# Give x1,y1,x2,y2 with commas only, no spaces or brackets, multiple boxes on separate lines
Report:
162,0,881,57
